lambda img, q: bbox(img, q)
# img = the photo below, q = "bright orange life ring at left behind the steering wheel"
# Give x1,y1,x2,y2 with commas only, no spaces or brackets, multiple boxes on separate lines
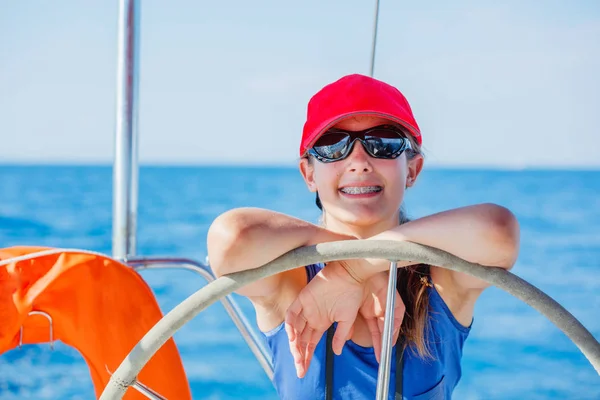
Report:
0,247,191,400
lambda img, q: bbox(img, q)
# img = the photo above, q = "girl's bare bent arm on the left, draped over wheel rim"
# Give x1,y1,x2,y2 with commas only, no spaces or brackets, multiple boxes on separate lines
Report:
207,208,354,298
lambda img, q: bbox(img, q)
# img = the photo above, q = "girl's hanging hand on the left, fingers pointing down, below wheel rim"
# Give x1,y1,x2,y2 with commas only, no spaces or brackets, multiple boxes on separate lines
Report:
285,261,366,378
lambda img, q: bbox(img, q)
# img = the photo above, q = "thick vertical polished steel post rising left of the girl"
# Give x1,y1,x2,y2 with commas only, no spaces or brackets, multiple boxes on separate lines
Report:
112,0,140,259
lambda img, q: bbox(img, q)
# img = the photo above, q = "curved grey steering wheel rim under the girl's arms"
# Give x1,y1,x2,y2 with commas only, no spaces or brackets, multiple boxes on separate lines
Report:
100,240,600,400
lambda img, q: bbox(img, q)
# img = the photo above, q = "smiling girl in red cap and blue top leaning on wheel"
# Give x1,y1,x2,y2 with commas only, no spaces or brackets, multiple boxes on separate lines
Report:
208,75,519,399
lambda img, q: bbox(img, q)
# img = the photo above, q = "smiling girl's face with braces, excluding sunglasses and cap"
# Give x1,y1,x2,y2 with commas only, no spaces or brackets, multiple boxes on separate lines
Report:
300,116,423,237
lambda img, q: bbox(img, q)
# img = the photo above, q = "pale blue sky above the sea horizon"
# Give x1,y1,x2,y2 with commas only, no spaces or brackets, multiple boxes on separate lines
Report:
0,0,600,168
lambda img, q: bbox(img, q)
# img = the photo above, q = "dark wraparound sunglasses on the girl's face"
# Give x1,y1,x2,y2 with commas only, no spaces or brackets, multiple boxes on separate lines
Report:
308,125,412,163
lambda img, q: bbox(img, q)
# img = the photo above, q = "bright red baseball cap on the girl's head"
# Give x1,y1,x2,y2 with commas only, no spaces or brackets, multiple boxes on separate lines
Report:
300,74,422,157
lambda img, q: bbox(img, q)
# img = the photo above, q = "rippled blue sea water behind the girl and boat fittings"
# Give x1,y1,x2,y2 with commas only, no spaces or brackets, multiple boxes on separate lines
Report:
0,165,600,400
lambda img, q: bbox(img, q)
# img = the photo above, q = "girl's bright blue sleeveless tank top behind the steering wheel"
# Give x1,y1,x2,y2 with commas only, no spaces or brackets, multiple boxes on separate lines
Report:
264,265,471,400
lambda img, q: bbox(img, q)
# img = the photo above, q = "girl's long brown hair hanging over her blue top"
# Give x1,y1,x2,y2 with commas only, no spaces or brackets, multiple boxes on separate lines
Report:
308,130,431,358
